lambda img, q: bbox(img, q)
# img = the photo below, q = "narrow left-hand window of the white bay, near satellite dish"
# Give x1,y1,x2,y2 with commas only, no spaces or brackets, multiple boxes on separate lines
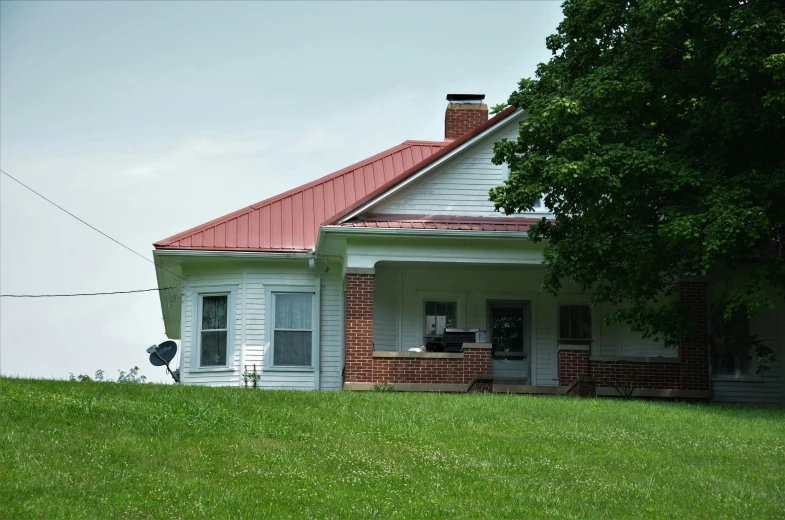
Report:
199,294,229,367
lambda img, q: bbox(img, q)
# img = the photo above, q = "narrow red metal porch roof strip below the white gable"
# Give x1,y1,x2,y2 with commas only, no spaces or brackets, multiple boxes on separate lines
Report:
335,215,540,231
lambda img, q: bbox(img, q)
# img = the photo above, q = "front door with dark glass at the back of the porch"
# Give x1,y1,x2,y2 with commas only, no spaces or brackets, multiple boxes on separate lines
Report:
488,302,531,384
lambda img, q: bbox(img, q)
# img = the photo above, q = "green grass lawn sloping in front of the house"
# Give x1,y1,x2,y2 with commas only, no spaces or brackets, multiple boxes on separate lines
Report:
0,379,785,519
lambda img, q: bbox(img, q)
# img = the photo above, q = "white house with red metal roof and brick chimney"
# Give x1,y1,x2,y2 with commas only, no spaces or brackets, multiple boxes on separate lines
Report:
154,95,785,405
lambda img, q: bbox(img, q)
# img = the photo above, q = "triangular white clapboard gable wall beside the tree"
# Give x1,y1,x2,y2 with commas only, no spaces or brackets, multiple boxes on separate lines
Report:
370,117,531,217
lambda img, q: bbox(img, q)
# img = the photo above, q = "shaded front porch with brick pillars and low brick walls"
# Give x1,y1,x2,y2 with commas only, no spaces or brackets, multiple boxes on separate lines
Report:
344,261,709,399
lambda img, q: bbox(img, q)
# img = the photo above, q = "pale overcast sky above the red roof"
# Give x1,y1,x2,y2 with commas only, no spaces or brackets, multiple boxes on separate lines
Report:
0,1,562,381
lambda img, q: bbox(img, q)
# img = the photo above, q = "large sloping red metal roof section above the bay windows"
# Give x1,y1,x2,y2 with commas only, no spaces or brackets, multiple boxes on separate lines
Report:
153,141,449,251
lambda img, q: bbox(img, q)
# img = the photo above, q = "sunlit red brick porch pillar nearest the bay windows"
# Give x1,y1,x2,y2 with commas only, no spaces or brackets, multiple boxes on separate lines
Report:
343,269,374,383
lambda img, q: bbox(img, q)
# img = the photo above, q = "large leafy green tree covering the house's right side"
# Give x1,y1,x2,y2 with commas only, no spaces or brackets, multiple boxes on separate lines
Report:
490,0,785,355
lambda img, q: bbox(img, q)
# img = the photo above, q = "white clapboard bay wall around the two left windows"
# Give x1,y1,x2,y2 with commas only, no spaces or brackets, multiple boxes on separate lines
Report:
180,262,343,390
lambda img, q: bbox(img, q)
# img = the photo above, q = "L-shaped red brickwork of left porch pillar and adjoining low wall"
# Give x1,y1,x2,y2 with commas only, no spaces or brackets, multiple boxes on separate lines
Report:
344,274,491,384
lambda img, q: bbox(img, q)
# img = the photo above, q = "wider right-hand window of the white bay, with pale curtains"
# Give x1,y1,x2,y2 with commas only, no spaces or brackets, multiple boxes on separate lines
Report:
272,293,313,367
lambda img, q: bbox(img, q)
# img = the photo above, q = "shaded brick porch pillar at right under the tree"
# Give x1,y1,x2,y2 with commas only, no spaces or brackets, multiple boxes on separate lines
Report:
679,281,710,390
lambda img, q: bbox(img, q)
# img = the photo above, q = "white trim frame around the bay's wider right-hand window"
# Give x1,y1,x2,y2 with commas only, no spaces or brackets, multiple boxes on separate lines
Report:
263,285,321,372
